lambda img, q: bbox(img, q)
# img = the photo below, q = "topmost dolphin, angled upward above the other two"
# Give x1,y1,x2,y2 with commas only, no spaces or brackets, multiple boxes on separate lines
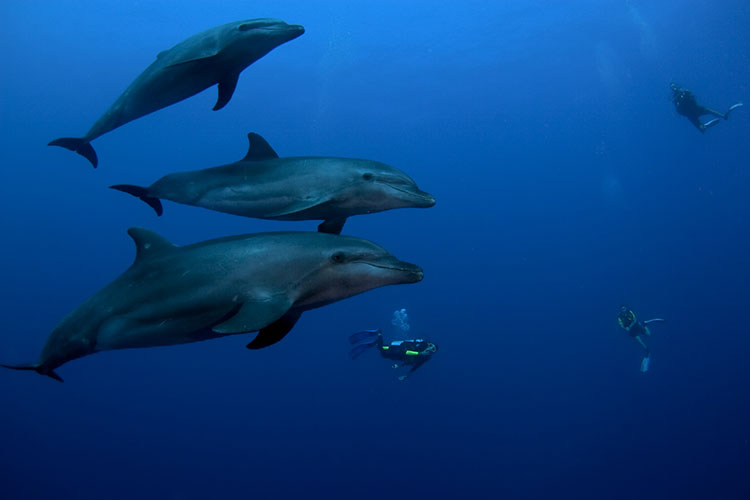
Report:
49,19,305,168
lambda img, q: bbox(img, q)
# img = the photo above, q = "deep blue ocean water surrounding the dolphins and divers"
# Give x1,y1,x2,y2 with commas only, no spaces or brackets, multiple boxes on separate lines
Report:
0,0,750,499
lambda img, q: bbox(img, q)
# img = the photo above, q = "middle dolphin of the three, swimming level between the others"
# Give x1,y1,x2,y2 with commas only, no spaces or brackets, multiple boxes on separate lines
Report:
110,133,435,234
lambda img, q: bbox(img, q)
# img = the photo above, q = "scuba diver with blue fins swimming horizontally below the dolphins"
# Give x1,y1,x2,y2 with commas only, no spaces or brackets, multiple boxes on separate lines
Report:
349,329,438,380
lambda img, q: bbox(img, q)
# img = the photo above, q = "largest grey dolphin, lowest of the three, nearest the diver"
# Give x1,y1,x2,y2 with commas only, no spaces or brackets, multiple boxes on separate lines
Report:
0,228,422,381
